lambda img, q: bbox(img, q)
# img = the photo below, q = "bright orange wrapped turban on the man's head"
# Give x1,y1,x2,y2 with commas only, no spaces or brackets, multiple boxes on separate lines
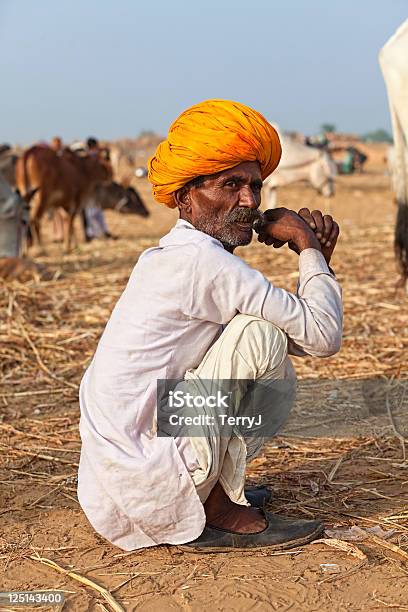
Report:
148,100,282,208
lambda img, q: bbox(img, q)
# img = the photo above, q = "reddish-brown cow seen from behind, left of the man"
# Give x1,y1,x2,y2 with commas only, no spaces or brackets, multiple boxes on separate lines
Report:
16,145,112,251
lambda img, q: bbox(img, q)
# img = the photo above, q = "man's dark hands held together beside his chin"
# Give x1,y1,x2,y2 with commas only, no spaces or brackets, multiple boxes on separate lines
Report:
258,208,340,264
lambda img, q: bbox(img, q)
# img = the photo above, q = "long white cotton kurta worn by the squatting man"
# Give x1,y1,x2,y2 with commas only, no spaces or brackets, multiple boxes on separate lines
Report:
78,220,342,550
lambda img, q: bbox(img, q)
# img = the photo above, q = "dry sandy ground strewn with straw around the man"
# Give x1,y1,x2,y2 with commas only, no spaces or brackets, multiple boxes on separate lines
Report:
0,155,408,612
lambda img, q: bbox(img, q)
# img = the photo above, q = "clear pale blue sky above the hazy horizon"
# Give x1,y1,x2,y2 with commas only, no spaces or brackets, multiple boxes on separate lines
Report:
0,0,408,144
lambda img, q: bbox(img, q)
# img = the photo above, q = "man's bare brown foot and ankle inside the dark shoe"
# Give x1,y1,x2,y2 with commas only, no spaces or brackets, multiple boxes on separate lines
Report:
204,482,267,533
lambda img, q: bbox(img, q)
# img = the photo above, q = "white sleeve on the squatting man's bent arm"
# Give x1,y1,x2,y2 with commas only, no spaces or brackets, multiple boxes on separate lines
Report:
188,246,343,357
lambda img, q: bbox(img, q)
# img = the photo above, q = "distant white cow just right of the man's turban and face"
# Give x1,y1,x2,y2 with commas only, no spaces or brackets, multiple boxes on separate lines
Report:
263,131,337,208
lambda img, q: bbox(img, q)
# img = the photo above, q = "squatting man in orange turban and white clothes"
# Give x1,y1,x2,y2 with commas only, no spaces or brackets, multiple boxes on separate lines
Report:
78,100,342,551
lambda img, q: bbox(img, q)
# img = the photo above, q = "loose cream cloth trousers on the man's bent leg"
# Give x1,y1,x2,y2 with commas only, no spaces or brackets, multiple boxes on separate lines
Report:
176,314,296,505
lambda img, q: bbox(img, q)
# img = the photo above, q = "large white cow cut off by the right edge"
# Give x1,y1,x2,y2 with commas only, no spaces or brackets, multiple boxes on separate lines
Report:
379,19,408,288
